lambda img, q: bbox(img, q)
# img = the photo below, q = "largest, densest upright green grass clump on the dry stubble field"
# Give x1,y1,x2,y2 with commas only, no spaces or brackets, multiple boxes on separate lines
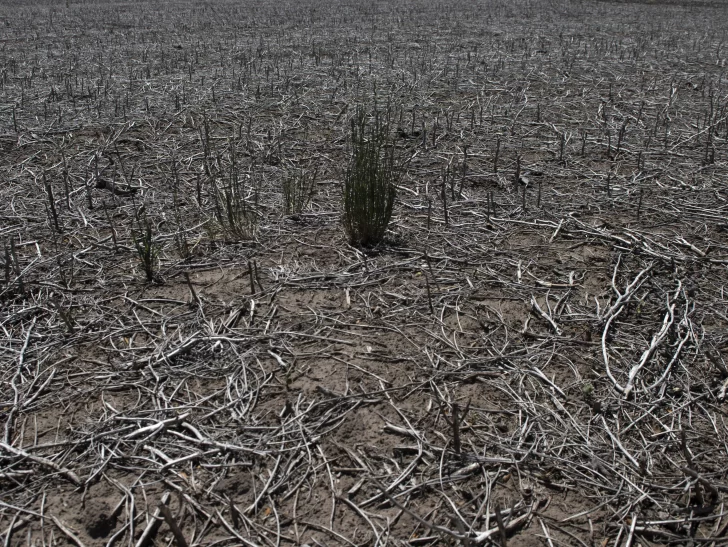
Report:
343,108,402,247
